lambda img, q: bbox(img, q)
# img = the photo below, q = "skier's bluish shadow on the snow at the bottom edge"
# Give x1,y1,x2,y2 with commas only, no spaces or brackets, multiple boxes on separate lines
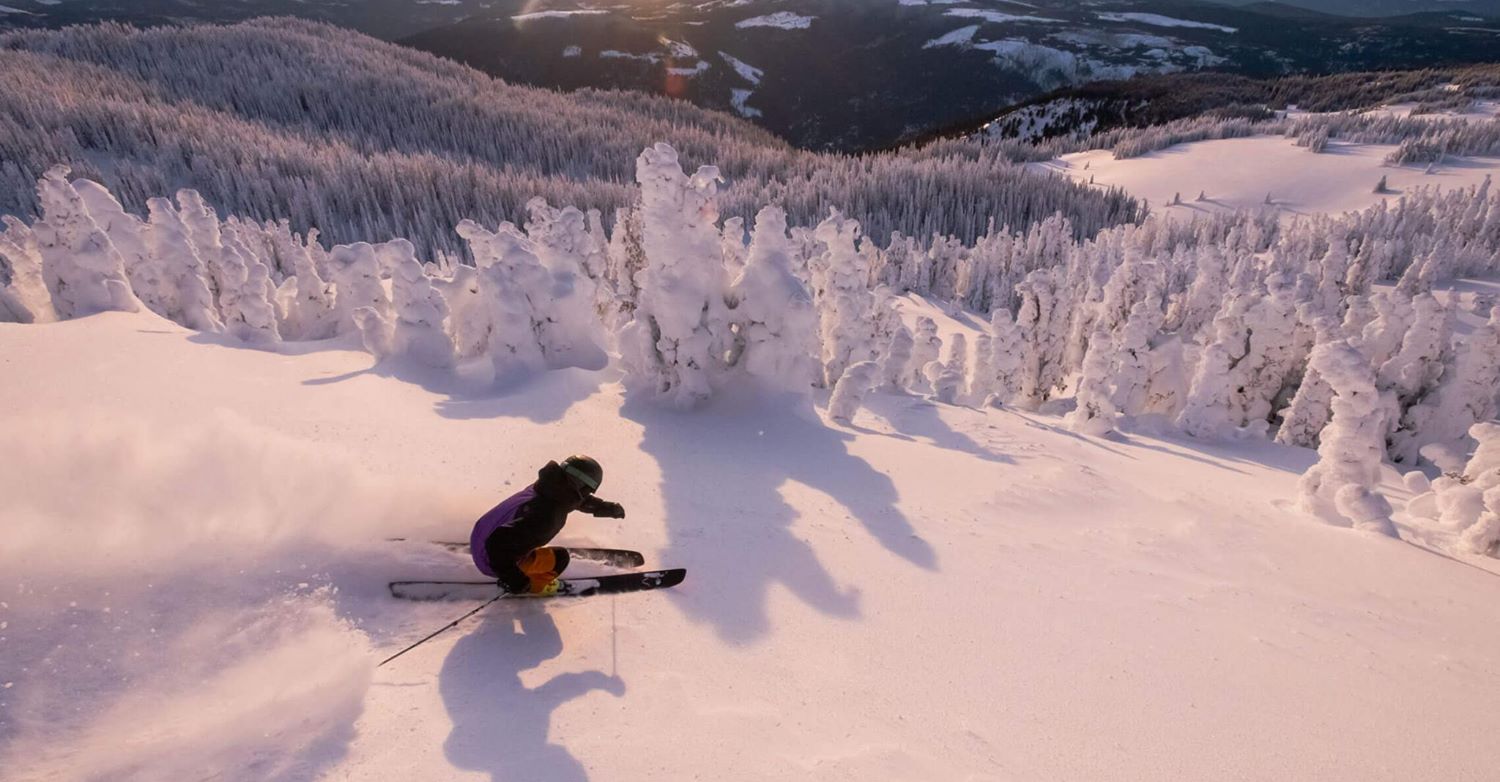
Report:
438,605,626,782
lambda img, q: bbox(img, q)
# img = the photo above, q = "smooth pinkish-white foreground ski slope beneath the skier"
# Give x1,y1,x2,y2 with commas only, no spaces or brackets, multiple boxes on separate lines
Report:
0,307,1500,780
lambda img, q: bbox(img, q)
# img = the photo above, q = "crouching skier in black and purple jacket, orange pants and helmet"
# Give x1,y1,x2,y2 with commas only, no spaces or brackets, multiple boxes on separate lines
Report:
470,456,626,594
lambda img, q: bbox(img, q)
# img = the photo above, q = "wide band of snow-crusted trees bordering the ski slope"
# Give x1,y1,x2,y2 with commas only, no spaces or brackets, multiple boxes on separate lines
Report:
0,144,1500,552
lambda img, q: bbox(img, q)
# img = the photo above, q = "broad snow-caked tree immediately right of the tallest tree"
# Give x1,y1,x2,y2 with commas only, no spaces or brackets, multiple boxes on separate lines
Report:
729,206,822,392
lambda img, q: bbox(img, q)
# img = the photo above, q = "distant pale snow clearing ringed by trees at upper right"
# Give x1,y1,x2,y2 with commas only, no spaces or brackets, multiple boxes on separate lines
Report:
1034,135,1500,219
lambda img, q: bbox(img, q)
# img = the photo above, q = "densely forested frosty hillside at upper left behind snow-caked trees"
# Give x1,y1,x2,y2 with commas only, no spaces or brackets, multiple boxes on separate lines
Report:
0,18,1137,255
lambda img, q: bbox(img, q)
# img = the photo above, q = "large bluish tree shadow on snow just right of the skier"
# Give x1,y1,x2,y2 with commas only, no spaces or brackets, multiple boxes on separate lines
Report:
623,390,938,642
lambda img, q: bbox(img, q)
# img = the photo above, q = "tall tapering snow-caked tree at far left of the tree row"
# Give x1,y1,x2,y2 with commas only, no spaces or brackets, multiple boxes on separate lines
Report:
32,165,140,318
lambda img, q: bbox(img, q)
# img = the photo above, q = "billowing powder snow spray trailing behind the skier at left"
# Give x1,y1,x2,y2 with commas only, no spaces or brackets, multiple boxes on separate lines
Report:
0,410,468,779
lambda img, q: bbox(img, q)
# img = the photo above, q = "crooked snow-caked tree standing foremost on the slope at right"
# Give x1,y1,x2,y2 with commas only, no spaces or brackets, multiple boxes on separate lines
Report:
1298,339,1395,537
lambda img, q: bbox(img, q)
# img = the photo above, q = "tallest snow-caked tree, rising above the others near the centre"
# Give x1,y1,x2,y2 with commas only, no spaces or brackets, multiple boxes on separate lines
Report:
620,144,731,407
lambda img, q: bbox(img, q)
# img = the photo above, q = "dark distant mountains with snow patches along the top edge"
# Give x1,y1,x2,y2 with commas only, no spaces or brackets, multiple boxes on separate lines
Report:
0,0,1500,152
